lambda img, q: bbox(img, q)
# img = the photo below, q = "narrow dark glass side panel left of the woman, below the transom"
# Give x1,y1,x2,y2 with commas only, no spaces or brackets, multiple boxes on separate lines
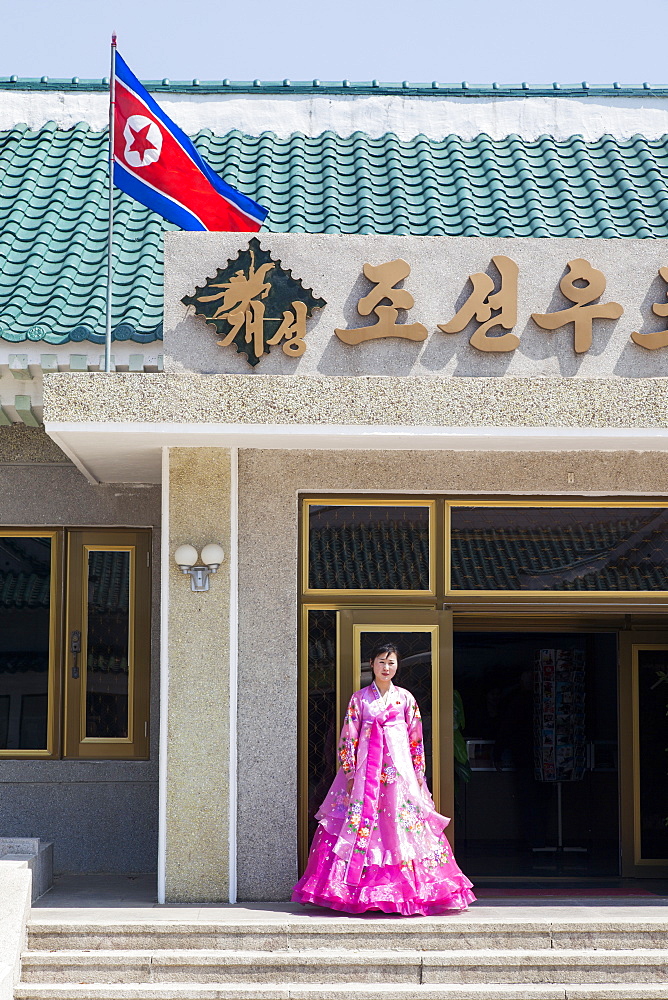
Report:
308,610,339,843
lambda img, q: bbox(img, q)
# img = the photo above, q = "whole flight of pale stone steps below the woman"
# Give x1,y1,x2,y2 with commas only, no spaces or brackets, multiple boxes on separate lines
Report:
15,908,668,1000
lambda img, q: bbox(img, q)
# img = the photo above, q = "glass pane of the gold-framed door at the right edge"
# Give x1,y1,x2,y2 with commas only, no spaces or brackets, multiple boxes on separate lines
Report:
637,649,668,860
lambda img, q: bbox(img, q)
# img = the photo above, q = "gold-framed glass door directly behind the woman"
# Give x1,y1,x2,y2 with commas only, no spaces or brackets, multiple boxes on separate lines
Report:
337,609,454,842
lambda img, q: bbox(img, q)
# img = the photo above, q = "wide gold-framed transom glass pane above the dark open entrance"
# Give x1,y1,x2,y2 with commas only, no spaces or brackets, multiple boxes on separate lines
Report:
450,507,668,592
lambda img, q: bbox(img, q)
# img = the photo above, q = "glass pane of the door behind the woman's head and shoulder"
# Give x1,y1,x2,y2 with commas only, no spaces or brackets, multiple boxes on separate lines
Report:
361,629,434,793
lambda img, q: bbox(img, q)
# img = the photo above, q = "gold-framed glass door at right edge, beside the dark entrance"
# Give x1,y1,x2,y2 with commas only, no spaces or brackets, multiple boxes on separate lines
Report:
620,632,668,878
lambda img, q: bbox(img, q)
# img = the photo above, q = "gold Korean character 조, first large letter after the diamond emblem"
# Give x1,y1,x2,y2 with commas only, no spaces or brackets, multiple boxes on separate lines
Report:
334,260,427,344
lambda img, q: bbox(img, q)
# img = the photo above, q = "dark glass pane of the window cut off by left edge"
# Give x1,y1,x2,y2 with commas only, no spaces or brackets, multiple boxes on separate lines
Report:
0,536,52,750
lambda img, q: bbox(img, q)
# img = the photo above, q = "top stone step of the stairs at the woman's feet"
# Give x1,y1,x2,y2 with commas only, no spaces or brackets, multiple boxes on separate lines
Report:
29,916,668,953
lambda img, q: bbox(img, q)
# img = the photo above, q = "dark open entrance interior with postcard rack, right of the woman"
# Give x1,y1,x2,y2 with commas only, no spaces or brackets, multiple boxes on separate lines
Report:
454,631,619,877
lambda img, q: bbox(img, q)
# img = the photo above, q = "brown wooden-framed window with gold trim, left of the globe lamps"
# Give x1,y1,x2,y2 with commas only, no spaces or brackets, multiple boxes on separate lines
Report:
0,528,151,760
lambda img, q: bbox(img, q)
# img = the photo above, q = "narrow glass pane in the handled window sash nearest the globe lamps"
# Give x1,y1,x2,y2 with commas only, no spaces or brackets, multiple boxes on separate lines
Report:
86,551,130,739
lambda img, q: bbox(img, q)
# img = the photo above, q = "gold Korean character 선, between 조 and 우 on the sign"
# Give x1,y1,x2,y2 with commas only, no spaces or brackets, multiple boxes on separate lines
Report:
438,255,520,352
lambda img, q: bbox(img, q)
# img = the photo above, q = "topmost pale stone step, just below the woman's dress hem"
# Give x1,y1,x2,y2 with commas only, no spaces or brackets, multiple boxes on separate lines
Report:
28,916,668,953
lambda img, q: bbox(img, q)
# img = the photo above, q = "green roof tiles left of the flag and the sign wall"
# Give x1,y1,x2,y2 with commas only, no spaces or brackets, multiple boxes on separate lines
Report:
0,124,163,344
